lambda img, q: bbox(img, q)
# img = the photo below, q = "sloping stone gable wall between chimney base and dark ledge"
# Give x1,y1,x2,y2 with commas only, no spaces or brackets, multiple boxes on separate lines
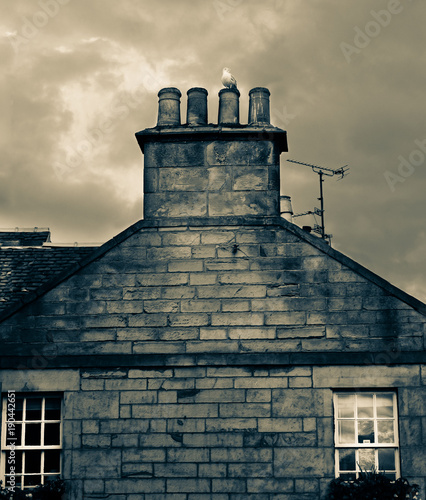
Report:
1,220,425,360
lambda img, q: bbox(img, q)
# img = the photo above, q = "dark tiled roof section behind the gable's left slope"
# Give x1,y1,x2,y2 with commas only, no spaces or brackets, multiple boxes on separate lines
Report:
0,231,94,314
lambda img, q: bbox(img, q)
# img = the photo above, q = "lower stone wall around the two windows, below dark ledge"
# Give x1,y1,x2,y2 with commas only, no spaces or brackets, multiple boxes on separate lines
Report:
1,365,426,500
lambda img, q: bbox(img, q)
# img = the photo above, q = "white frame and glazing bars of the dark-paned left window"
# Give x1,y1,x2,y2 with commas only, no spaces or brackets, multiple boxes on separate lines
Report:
0,392,63,490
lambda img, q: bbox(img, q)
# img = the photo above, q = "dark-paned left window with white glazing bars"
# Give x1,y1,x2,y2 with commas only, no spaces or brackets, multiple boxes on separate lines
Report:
1,392,62,488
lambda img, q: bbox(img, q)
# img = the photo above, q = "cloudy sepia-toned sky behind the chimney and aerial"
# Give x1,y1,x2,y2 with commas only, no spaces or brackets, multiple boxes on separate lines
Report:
0,0,426,301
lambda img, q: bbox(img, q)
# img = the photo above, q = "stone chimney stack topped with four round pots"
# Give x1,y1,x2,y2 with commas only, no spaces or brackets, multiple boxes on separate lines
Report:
136,87,287,220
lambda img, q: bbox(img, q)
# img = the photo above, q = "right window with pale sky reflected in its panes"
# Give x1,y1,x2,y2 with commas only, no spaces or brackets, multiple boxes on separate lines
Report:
334,392,399,480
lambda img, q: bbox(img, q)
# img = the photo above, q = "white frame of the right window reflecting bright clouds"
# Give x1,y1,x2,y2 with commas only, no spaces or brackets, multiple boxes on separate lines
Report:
333,389,401,479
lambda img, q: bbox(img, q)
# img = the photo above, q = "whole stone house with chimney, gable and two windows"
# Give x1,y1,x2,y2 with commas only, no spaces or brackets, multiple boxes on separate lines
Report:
0,88,426,500
